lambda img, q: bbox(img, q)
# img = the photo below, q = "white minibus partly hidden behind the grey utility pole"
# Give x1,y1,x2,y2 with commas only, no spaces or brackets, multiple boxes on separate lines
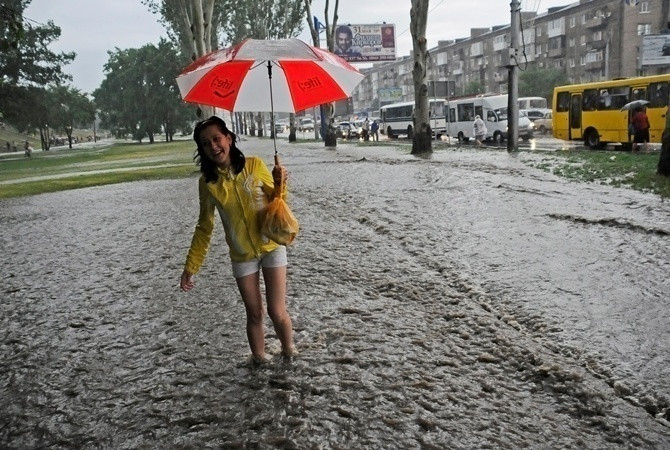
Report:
445,94,533,142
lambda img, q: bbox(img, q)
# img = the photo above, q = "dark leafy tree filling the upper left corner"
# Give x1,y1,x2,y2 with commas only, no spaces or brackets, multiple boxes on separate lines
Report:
0,0,75,131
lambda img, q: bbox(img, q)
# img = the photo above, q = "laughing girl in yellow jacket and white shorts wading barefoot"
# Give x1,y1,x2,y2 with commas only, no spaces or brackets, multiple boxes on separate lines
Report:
180,116,295,362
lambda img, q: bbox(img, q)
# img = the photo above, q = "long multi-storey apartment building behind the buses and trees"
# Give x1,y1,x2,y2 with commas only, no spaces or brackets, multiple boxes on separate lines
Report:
352,0,670,111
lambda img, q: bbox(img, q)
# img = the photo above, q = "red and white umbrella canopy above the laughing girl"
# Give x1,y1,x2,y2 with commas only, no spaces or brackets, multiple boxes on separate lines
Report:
177,39,364,113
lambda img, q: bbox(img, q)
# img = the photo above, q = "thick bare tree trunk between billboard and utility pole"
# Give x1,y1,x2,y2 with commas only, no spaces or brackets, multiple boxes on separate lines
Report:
409,0,433,154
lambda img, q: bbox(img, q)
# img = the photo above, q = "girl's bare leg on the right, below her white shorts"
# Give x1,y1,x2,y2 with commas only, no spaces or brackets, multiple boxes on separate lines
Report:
263,266,295,356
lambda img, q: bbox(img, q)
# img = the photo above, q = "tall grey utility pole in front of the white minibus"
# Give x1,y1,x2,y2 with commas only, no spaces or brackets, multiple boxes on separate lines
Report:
507,0,521,152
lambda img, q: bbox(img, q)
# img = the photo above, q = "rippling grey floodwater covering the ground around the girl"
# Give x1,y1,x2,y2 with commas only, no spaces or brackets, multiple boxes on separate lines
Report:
0,139,670,449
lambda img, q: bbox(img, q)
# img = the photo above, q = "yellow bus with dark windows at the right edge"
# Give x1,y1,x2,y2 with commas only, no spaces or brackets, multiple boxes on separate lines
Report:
552,74,670,149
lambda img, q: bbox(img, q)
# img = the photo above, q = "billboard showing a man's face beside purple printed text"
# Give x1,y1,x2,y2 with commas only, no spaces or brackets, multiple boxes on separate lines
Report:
334,23,395,62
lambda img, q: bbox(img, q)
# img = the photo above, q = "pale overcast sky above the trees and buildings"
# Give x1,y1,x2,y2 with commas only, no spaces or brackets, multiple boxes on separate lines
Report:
25,0,573,93
